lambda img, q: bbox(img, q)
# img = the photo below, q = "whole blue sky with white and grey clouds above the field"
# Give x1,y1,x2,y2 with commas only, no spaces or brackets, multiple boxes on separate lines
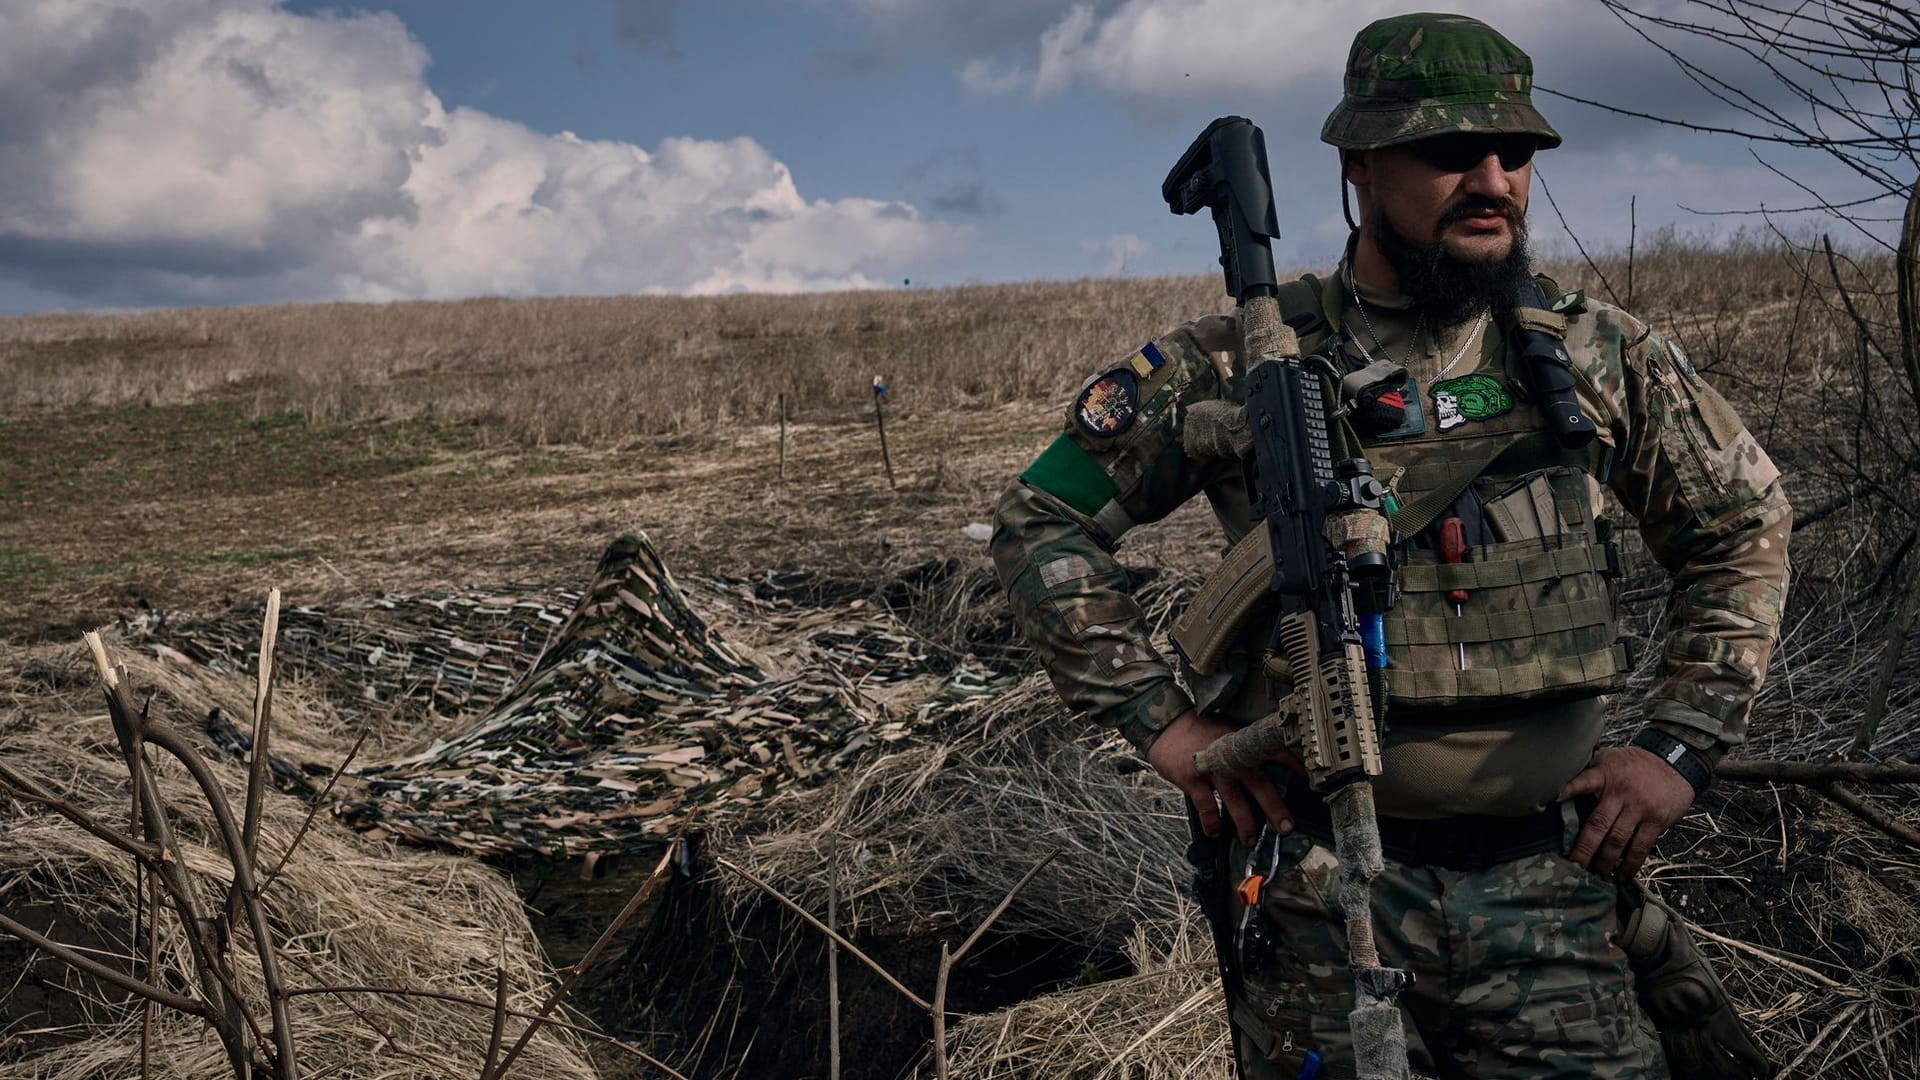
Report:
0,0,1891,311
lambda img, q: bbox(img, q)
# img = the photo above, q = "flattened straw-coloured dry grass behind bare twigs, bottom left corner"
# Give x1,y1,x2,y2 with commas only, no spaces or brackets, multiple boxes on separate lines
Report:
0,648,593,1080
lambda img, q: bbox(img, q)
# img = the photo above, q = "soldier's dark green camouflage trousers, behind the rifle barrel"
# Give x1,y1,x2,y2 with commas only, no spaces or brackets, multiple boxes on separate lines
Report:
1227,813,1668,1080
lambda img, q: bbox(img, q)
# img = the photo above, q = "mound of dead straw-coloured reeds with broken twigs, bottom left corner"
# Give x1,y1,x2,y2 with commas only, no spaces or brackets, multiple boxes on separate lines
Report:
0,630,593,1080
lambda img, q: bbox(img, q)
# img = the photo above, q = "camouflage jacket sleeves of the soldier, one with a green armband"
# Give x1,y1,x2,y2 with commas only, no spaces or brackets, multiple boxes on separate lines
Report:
991,272,1791,761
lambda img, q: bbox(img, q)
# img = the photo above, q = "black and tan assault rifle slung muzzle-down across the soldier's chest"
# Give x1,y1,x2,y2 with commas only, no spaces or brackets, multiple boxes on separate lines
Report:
1160,117,1413,1080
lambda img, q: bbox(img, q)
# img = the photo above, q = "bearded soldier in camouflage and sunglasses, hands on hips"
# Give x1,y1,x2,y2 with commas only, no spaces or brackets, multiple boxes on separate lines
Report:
993,13,1791,1080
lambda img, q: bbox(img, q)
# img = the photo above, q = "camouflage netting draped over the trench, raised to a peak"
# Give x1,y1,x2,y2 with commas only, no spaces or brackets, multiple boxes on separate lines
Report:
152,534,996,855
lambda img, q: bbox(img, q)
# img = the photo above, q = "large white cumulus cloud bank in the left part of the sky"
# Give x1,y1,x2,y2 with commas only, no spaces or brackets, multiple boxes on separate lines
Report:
0,0,968,304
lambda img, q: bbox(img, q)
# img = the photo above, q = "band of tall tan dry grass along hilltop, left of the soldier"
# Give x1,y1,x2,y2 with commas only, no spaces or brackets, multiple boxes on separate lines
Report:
0,279,1225,446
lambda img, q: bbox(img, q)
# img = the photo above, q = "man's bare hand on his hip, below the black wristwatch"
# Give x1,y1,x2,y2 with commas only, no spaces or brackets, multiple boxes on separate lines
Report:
1561,746,1693,878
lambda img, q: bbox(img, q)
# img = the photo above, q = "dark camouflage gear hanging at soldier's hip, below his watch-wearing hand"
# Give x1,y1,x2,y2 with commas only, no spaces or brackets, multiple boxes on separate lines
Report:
1620,886,1776,1080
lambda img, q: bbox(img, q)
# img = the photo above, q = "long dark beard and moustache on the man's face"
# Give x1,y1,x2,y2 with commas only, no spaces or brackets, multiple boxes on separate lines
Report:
1373,198,1530,327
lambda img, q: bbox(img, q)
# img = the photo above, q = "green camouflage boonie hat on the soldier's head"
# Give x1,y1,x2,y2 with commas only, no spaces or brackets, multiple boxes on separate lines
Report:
1321,12,1561,150
